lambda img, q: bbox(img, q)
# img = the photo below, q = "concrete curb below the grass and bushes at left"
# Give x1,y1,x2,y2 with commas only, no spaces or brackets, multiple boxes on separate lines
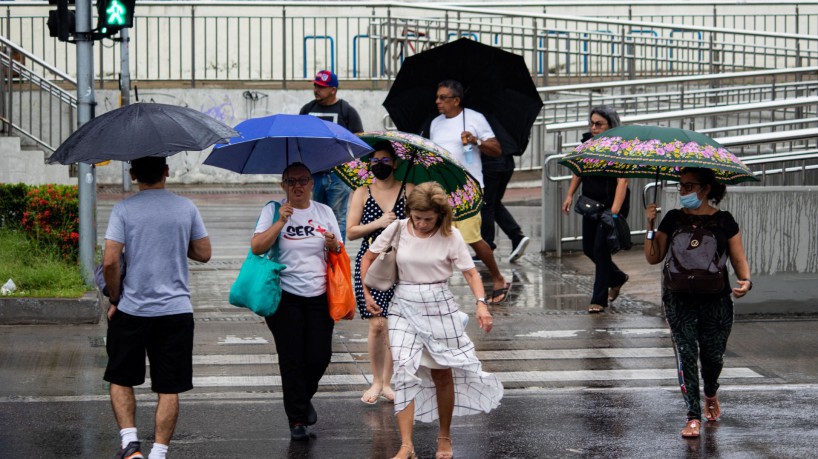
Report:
0,290,102,325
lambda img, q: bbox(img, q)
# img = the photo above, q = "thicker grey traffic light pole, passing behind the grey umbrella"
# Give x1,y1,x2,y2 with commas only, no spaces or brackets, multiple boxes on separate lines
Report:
76,0,97,285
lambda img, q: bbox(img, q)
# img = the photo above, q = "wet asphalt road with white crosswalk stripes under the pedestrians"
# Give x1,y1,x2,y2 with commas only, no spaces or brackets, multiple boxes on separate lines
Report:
0,189,818,458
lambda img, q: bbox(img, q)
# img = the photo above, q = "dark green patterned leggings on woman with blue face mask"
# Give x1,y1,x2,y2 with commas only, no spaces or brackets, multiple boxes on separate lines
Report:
662,291,733,419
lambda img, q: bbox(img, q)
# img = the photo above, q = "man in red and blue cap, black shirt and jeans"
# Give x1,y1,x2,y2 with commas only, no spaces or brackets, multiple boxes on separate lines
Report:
298,70,364,240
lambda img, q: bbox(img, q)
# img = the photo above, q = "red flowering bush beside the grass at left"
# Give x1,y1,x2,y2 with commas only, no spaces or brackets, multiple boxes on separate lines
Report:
21,185,80,262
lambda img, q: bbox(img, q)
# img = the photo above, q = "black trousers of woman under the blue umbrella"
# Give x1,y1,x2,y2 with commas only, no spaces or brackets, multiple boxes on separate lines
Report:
265,291,335,426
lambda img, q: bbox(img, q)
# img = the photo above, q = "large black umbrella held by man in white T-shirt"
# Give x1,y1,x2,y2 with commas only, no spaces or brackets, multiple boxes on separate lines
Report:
383,38,543,154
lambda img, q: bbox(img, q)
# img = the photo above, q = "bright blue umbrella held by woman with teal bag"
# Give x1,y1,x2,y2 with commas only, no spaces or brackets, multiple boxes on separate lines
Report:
204,115,372,174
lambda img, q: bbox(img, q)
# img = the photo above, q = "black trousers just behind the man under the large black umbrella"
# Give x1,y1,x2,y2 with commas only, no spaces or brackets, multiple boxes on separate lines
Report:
480,157,523,250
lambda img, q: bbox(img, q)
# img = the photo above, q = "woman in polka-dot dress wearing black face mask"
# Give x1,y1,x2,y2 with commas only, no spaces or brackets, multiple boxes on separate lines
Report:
347,140,413,405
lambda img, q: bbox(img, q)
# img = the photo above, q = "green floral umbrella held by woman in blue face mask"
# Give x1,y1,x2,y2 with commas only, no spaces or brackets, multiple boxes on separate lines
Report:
560,126,758,184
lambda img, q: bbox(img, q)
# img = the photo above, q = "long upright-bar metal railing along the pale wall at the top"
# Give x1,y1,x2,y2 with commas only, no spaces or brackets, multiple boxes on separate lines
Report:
0,1,818,86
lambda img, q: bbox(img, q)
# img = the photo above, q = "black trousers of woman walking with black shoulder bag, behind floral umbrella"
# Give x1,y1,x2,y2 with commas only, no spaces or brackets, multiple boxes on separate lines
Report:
582,217,625,308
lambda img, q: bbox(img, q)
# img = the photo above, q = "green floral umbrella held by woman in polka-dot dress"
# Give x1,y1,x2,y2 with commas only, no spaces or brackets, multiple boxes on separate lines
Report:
333,131,483,221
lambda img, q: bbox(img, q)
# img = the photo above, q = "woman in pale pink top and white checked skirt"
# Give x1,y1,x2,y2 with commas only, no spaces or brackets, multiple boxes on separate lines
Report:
361,182,503,459
